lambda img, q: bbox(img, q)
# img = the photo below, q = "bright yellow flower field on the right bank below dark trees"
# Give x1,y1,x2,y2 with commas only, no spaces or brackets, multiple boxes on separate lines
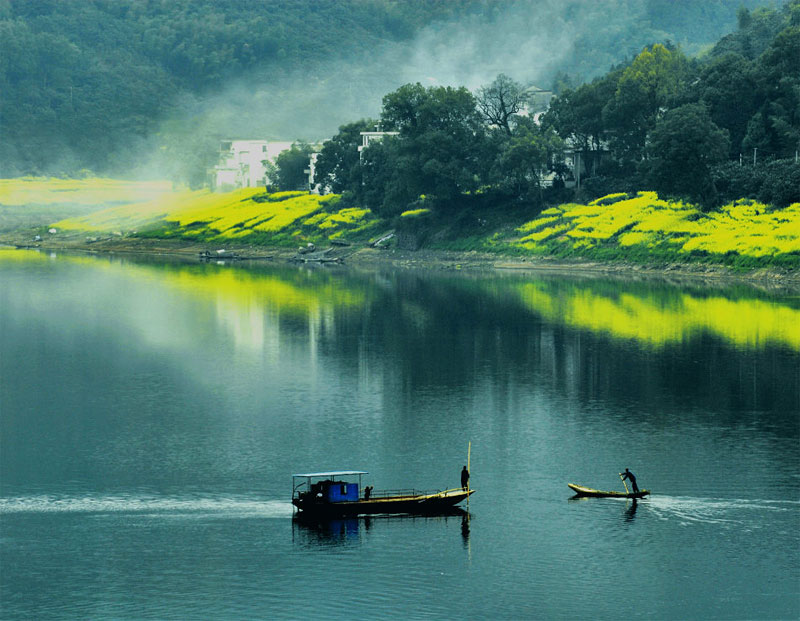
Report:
515,192,800,263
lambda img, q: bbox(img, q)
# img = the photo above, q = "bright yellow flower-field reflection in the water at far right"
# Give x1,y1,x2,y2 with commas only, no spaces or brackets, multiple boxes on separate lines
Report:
518,283,800,351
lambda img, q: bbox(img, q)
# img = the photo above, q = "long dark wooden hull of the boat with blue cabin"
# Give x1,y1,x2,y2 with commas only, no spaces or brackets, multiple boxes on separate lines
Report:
292,490,475,516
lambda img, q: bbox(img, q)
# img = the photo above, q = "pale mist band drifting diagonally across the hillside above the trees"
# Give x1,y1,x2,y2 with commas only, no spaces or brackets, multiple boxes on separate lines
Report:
177,0,780,141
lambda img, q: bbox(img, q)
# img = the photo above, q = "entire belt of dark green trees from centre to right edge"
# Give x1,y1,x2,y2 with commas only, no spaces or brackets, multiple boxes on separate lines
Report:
308,0,800,217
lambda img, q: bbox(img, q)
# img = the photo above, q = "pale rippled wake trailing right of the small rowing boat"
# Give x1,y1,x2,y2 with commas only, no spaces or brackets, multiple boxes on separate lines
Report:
647,495,800,524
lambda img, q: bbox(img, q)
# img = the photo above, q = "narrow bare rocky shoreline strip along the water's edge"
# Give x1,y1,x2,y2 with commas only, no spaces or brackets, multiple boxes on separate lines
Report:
0,236,800,291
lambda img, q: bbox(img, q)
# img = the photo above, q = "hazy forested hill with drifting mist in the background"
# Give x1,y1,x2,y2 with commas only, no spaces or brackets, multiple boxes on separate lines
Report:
0,0,782,180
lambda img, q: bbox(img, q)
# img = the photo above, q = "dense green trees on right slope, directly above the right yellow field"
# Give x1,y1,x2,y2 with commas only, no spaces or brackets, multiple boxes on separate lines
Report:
545,0,800,205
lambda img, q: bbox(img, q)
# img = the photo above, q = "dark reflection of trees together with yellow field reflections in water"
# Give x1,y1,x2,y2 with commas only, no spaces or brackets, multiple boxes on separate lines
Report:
130,254,800,424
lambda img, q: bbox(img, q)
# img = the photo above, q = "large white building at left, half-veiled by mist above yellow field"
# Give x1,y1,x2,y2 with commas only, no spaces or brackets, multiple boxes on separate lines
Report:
211,140,292,191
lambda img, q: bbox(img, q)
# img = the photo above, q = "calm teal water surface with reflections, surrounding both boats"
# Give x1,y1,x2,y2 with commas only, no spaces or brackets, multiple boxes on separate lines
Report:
0,251,800,619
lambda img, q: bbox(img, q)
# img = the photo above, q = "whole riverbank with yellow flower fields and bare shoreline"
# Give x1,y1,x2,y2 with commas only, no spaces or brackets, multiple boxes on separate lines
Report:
0,179,800,288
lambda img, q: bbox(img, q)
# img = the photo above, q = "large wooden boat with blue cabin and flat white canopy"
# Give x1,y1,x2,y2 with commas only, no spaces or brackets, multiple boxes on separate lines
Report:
292,470,475,516
